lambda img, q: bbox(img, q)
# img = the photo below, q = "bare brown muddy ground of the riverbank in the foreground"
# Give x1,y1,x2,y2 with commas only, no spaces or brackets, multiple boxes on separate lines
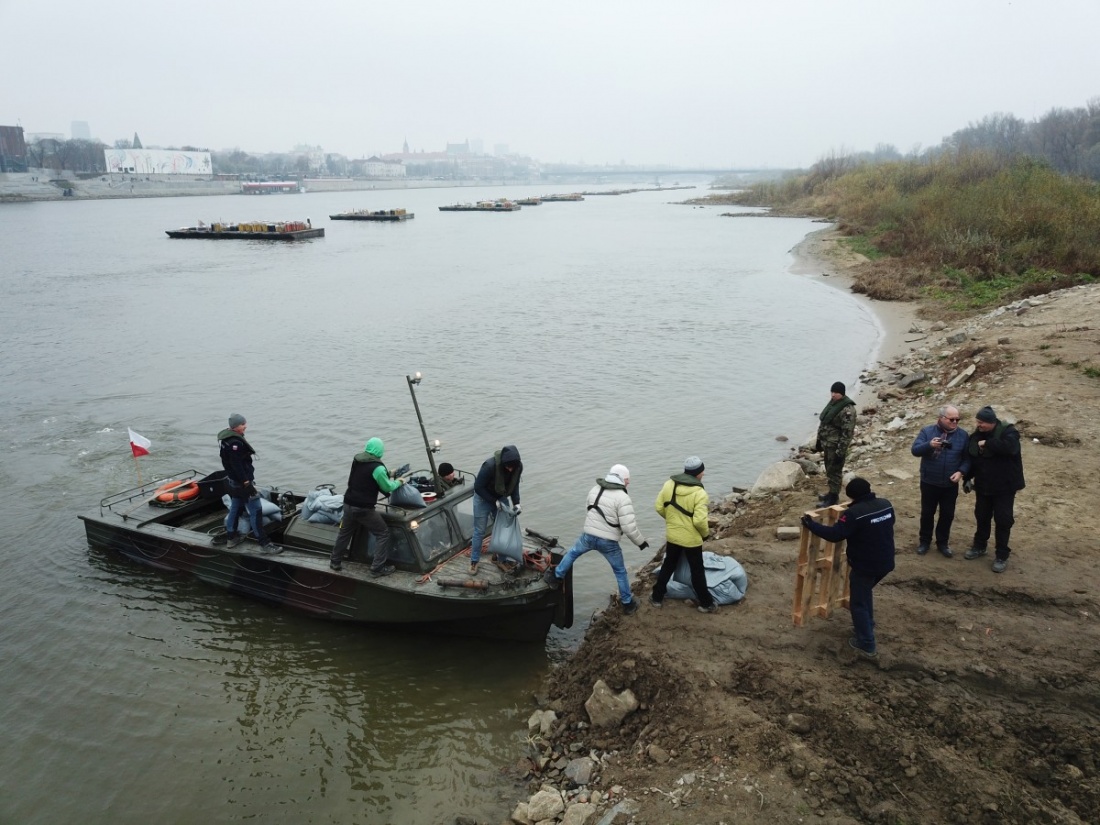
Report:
514,238,1100,825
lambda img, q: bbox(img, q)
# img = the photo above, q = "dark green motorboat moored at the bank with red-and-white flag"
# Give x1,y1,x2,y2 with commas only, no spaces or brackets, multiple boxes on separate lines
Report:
80,373,573,641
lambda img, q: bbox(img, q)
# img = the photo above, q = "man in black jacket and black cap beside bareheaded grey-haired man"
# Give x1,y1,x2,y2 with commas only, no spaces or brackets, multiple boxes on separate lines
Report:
963,406,1024,573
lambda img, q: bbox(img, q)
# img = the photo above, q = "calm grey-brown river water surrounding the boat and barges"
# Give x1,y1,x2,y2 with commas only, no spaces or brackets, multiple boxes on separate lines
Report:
0,185,881,825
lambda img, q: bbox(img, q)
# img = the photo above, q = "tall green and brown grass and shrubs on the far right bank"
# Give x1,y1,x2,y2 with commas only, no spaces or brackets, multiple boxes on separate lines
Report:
738,153,1100,311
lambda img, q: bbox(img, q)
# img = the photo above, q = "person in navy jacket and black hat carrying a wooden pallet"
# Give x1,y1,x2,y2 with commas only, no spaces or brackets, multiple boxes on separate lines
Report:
802,476,897,658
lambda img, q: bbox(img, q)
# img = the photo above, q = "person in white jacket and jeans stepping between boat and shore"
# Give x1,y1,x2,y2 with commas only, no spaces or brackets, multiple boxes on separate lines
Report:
543,464,649,616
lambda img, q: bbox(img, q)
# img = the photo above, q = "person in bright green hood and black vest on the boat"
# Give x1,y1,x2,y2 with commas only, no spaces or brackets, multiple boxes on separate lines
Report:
329,438,405,579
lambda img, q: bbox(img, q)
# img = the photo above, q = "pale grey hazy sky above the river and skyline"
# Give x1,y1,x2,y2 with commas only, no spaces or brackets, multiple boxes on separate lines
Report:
0,0,1100,167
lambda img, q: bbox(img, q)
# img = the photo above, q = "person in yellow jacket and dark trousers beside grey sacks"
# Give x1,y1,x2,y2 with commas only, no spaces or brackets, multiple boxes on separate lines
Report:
649,455,718,613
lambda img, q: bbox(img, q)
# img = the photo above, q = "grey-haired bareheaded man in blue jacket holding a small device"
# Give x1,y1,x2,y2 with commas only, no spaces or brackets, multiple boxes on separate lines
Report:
911,405,970,559
